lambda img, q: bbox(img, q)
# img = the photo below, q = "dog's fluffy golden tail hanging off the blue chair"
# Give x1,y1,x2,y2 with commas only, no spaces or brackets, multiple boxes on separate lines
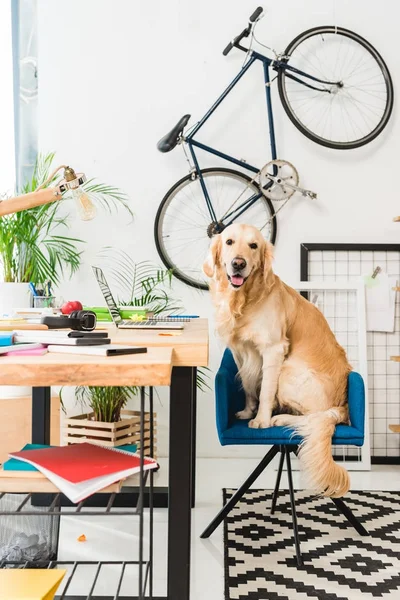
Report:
295,408,350,498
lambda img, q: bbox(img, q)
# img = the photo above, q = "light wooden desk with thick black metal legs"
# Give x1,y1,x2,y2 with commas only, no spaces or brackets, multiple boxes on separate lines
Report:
0,319,208,600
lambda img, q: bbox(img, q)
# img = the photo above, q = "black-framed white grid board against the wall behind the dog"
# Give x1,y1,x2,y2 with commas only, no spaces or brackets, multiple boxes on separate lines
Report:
301,244,400,463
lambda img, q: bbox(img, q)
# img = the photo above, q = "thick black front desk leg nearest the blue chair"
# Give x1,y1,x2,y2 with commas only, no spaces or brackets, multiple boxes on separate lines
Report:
168,367,194,600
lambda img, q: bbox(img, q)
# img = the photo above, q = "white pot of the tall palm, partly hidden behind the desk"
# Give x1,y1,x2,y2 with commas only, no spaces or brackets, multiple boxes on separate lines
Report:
0,282,32,399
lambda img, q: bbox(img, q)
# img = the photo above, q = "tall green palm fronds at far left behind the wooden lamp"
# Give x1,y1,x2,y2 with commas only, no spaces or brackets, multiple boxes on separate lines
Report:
0,153,132,284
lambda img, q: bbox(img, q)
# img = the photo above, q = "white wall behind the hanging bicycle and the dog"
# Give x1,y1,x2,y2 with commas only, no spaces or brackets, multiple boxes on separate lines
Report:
38,0,400,456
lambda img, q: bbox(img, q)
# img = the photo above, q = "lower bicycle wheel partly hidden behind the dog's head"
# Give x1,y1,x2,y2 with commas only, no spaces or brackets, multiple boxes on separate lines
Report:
154,168,276,290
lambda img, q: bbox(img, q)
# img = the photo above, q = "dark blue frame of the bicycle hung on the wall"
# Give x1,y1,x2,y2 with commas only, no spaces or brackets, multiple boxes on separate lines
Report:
183,47,336,227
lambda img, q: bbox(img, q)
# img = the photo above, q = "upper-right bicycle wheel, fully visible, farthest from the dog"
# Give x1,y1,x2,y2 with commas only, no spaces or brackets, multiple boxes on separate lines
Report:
278,26,393,149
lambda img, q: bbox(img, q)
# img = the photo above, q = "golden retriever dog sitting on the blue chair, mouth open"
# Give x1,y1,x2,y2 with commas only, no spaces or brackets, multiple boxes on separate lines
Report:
203,224,351,497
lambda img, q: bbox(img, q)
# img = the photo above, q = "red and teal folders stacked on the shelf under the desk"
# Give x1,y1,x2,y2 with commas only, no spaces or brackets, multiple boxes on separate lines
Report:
0,442,158,503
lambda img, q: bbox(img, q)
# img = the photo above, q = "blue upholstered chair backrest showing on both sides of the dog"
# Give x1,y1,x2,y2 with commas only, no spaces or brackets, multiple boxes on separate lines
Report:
215,348,365,434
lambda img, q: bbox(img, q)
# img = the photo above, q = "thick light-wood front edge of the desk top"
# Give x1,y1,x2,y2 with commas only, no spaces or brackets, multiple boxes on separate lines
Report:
0,346,173,387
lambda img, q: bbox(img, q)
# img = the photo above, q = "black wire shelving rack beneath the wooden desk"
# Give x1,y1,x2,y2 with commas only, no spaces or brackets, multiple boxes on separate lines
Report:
0,387,156,600
